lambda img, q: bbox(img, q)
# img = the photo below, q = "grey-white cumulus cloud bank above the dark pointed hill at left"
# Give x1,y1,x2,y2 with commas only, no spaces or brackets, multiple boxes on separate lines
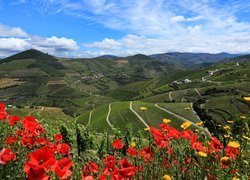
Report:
0,25,79,57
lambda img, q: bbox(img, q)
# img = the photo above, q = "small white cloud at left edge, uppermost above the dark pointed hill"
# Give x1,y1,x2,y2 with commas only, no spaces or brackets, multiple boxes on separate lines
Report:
0,24,28,37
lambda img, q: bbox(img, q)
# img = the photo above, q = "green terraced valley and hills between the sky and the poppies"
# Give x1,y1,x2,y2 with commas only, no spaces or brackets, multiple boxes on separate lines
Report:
0,50,250,136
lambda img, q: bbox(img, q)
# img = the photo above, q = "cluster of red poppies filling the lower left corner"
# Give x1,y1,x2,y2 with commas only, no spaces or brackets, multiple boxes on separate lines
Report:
0,104,73,180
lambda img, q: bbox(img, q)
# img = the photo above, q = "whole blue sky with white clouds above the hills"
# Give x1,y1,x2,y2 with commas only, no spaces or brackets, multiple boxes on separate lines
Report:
0,0,250,57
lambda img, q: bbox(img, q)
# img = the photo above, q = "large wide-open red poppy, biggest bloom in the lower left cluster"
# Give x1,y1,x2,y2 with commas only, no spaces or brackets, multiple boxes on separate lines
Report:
28,146,56,169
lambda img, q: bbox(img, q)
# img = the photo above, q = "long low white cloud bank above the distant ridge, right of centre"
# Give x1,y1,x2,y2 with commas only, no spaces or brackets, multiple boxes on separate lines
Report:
83,32,250,56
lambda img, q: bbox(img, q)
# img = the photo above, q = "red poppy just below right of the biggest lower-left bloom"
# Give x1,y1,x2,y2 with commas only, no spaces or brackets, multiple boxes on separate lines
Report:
54,158,73,179
